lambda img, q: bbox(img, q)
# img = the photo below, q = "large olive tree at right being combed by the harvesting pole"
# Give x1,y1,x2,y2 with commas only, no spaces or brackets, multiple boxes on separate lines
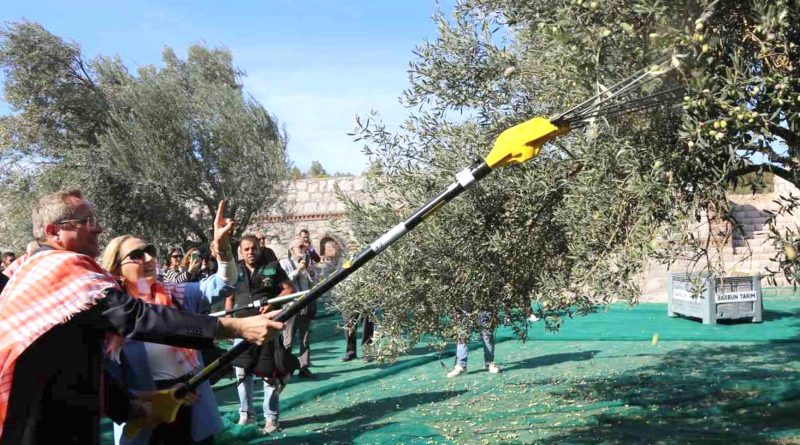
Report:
336,0,800,357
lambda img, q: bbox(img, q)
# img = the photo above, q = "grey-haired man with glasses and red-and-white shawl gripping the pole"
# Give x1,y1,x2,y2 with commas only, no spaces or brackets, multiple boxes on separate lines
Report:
0,190,283,444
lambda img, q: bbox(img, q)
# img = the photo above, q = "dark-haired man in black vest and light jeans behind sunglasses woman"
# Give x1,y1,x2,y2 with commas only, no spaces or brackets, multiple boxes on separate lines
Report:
225,235,294,434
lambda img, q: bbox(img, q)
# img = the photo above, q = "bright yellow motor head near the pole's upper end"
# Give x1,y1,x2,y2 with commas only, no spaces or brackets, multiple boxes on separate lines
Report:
485,117,570,169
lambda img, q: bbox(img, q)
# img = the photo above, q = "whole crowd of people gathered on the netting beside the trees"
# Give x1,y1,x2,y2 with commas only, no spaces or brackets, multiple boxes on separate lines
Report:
0,190,499,445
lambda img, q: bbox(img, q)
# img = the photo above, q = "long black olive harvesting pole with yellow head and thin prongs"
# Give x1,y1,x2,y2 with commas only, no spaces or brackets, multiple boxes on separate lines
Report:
125,58,683,437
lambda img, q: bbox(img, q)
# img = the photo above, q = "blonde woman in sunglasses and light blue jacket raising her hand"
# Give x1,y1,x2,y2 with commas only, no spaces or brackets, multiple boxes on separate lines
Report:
102,203,238,445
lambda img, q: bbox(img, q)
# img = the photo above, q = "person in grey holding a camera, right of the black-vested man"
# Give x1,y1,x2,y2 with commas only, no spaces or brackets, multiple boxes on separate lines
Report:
281,239,317,378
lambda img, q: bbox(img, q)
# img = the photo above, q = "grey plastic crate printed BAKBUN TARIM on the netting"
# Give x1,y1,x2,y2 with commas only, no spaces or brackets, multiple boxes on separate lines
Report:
667,273,764,324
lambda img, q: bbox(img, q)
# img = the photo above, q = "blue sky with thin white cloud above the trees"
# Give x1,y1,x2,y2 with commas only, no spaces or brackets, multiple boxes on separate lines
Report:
0,0,453,174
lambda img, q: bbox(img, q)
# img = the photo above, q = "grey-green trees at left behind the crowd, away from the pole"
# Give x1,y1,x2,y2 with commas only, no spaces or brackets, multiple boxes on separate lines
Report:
0,22,288,248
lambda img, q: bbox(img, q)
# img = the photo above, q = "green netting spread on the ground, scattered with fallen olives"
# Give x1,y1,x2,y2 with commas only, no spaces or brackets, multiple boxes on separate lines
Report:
100,297,800,445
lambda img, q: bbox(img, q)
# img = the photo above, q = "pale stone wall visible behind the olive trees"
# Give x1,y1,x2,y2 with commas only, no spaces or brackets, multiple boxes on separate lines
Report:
249,177,800,301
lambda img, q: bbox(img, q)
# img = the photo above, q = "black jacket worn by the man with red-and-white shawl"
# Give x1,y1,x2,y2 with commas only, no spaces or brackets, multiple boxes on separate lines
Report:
0,289,217,445
